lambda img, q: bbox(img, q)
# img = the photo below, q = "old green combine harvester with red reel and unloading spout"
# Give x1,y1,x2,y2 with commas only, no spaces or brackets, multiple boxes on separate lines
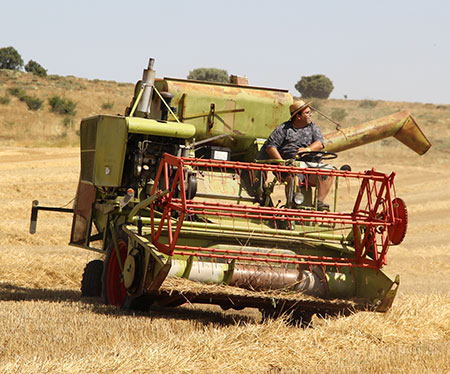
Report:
30,59,430,323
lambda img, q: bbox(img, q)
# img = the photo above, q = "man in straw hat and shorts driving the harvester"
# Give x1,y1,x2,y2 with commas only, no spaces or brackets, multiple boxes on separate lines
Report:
261,100,333,210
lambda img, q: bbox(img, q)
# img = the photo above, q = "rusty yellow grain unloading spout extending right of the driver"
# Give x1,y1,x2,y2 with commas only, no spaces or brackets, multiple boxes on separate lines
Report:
324,111,431,155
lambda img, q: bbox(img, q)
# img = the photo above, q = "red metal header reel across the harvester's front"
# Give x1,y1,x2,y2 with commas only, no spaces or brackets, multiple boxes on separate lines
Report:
151,154,407,269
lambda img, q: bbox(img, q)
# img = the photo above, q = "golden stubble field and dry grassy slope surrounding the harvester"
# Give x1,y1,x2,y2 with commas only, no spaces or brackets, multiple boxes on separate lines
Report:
0,69,450,374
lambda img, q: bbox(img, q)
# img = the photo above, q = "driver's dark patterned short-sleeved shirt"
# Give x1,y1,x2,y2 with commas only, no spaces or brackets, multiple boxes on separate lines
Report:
264,120,324,160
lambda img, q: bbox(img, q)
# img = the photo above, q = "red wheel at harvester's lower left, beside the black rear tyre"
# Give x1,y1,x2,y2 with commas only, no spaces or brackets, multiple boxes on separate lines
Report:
102,238,128,306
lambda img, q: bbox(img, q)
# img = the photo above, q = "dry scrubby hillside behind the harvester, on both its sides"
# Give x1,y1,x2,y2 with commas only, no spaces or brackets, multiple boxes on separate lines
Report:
0,70,450,152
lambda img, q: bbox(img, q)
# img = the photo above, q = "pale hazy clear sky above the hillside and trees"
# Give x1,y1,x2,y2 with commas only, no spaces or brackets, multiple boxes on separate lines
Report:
0,0,450,104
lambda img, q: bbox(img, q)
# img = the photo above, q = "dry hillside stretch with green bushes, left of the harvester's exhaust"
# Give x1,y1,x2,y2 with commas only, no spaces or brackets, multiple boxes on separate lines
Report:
0,70,134,146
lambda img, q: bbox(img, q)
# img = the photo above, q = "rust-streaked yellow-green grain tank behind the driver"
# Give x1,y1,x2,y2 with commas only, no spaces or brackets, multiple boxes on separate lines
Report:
152,78,293,160
